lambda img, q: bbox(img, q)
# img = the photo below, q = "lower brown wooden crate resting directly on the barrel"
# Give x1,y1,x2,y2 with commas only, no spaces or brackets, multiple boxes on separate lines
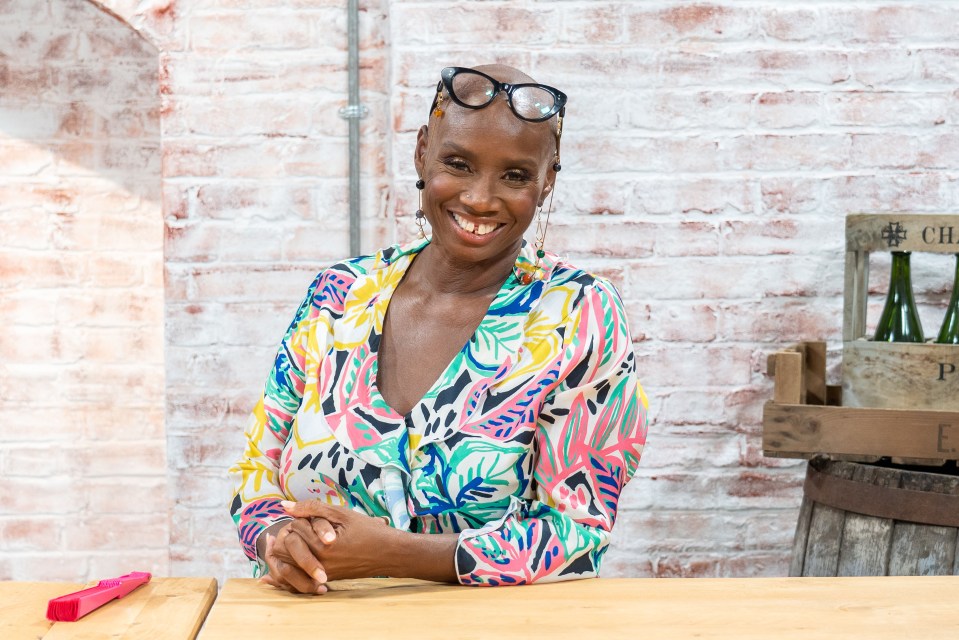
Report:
763,342,959,465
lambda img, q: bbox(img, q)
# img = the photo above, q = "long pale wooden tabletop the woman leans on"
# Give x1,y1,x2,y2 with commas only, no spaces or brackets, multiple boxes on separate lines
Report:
200,576,959,640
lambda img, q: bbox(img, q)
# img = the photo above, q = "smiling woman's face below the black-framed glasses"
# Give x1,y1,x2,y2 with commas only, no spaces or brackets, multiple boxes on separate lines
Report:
414,99,556,263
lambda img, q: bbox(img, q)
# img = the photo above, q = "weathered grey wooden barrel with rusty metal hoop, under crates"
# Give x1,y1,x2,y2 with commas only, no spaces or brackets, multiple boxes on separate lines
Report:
789,458,959,576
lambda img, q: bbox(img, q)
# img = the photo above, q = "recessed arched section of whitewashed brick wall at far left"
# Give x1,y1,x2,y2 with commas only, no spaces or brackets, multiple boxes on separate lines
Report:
0,0,170,581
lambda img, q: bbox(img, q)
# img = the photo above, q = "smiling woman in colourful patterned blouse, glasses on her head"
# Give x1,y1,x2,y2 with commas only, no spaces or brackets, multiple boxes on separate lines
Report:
231,65,646,593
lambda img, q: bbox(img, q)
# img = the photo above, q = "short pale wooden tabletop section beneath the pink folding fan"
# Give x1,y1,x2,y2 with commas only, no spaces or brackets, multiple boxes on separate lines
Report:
0,578,216,640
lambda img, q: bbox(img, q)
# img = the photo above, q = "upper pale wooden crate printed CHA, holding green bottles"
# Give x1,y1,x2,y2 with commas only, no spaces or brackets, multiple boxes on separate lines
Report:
842,213,959,411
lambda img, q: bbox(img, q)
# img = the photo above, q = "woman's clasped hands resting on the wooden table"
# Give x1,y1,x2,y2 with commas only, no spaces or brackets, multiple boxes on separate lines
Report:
261,500,392,594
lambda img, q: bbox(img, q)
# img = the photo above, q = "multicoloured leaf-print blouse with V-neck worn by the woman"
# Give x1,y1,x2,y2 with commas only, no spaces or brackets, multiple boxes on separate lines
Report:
230,239,647,585
